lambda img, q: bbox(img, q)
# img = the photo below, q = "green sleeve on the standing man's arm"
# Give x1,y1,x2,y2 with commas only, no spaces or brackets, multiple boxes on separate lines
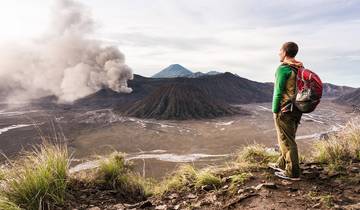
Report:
272,65,292,113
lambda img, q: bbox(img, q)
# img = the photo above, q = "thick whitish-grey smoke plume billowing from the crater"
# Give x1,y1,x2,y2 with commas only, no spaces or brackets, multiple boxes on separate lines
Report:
0,0,133,103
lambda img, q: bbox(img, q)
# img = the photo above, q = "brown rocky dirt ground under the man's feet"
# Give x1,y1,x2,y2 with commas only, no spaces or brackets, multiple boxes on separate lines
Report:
62,160,360,210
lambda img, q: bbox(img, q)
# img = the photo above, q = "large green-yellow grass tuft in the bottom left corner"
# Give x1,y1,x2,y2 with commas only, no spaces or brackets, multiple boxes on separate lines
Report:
1,144,69,210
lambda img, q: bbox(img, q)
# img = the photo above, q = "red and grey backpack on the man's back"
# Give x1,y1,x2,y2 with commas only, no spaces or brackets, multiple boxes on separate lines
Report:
291,66,323,113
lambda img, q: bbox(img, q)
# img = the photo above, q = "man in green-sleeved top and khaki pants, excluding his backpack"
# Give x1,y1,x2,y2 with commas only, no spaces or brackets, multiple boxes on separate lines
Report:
269,42,303,180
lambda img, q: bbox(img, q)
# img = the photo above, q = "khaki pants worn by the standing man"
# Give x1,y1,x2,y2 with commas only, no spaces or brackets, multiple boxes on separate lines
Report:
274,109,302,177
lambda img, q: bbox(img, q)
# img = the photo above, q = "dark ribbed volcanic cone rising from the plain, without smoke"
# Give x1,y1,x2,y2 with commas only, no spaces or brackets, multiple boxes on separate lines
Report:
125,83,246,120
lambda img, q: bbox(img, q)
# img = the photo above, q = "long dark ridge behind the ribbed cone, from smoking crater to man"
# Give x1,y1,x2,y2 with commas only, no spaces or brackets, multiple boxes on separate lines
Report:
73,72,273,110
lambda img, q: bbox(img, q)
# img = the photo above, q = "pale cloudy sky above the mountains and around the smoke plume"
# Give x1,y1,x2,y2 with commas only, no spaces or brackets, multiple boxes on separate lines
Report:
0,0,360,87
